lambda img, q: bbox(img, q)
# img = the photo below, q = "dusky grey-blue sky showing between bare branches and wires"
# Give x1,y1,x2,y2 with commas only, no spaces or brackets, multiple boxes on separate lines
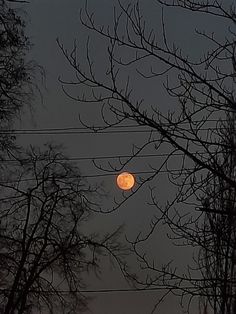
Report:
11,0,232,314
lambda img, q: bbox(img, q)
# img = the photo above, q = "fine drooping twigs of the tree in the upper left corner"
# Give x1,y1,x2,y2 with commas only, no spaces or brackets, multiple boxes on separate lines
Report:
0,0,43,159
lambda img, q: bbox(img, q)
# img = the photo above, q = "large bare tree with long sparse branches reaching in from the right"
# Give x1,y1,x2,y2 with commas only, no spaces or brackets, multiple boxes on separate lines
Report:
58,0,236,314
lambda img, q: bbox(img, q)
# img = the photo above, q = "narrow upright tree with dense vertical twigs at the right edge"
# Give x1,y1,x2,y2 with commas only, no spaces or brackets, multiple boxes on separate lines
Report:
198,106,236,314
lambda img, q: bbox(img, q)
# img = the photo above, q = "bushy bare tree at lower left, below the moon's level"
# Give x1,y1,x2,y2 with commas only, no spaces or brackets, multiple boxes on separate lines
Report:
0,146,125,314
